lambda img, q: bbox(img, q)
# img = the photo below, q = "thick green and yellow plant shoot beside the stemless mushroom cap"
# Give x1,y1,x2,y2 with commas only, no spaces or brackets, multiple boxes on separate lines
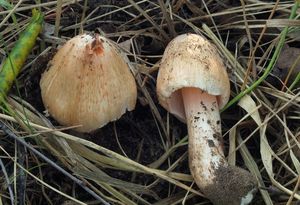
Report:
0,10,44,103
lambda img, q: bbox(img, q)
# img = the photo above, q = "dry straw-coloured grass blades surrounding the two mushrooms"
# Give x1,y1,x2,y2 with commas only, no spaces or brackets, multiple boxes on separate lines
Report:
0,0,300,205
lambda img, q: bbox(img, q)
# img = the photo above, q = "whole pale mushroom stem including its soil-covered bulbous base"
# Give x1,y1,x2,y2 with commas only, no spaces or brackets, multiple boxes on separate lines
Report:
181,88,256,205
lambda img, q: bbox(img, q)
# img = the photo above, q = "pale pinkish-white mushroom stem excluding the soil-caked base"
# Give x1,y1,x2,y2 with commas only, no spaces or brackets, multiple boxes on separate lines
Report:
181,88,227,188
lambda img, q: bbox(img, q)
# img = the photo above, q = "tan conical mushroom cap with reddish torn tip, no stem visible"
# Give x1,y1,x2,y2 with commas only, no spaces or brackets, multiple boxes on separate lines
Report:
40,34,137,132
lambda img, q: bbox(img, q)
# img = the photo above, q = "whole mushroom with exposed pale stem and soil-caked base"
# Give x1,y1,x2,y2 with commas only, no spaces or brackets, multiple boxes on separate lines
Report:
157,34,256,205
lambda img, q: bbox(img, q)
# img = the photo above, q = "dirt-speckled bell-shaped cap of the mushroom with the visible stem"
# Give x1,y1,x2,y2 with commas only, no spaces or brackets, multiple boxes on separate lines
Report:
157,34,230,121
